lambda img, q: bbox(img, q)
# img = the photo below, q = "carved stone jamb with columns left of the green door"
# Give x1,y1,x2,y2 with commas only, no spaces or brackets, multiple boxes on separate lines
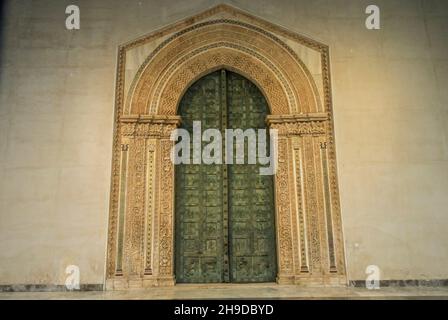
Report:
107,116,180,289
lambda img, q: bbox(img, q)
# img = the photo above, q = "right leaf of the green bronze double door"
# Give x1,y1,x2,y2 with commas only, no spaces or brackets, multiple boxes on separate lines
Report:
227,73,276,282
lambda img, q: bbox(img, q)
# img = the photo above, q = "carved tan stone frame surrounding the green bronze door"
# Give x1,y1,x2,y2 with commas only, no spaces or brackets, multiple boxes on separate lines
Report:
106,5,346,289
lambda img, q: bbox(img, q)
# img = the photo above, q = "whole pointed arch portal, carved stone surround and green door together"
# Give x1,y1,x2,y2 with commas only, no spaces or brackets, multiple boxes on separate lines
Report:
106,5,346,289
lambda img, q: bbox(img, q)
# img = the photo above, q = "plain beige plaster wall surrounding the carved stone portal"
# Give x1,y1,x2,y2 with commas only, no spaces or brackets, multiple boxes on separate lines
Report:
0,0,448,284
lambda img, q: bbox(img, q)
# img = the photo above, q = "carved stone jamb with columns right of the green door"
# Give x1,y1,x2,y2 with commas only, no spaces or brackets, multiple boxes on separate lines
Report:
267,113,345,285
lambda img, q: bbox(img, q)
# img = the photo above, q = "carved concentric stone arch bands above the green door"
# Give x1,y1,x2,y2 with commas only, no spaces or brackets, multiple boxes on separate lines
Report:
124,20,320,115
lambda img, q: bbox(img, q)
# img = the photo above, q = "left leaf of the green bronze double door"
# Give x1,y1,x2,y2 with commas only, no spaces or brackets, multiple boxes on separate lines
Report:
175,72,223,283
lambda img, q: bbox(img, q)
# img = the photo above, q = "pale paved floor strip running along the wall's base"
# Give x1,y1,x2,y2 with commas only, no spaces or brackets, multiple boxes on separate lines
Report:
0,284,448,300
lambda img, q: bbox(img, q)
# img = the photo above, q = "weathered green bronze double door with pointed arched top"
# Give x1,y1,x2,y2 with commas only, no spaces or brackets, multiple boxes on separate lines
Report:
175,70,276,283
